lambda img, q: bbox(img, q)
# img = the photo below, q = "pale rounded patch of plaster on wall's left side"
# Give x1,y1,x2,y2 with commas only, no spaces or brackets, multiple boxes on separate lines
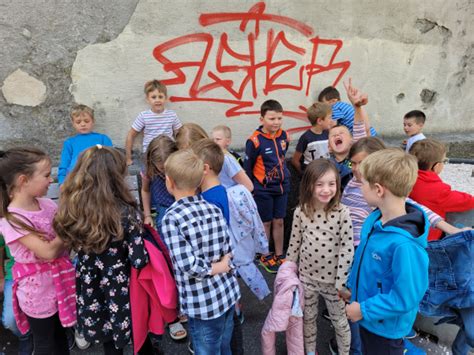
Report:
2,69,46,107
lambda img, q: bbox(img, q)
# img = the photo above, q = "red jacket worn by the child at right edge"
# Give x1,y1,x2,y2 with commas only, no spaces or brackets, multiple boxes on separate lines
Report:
410,170,474,241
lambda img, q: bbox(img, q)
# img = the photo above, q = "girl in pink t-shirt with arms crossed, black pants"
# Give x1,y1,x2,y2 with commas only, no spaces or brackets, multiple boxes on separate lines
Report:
0,148,76,355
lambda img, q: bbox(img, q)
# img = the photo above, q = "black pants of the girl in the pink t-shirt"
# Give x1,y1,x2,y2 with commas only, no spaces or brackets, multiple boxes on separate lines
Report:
27,313,69,355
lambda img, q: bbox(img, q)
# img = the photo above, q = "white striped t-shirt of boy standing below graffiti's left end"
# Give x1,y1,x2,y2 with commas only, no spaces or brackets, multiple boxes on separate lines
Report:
132,110,182,153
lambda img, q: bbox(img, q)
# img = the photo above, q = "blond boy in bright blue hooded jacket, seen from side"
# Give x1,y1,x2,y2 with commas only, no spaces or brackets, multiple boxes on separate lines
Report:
343,149,429,355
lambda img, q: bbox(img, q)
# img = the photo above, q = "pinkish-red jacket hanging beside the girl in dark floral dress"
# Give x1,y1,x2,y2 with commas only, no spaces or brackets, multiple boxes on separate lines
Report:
130,225,178,354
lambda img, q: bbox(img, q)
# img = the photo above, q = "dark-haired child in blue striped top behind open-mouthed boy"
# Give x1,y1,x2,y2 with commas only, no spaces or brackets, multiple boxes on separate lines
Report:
318,86,377,136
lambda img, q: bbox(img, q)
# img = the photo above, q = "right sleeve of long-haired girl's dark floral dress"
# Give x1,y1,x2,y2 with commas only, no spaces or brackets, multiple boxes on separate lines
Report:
124,213,148,269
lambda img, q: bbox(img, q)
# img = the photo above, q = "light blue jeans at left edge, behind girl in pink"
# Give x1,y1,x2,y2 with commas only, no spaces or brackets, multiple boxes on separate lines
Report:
2,280,33,355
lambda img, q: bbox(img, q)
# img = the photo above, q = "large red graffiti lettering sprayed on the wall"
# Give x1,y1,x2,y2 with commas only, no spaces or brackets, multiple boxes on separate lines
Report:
153,2,351,132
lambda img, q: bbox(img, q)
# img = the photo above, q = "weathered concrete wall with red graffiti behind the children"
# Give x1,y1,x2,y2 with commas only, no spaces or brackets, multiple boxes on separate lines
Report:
0,0,474,162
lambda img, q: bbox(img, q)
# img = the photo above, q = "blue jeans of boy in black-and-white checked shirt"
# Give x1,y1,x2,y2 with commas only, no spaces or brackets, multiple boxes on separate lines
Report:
188,306,234,355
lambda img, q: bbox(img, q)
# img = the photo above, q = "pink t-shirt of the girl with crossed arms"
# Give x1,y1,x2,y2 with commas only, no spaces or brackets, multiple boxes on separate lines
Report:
0,198,58,318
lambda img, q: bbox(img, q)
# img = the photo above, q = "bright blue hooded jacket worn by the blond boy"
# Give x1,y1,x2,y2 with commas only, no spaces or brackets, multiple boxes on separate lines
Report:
349,202,429,339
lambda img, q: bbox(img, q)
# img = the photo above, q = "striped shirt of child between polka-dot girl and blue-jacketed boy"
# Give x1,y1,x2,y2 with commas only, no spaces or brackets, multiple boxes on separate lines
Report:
341,178,443,246
